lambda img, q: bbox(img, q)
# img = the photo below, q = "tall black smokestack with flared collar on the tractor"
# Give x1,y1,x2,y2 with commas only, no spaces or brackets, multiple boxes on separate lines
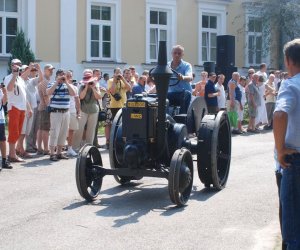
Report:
150,41,173,158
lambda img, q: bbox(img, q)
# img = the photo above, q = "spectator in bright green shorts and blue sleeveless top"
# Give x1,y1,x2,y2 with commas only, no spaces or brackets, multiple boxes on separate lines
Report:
227,72,242,134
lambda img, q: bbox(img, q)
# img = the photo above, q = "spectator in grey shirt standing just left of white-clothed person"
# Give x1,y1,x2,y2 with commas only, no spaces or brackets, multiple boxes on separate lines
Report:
247,73,260,133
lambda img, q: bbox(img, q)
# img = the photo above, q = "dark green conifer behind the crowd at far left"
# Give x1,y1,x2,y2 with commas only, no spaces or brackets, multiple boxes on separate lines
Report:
8,29,35,73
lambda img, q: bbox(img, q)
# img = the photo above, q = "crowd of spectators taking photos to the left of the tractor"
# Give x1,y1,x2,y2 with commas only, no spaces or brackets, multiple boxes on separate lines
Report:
0,59,162,170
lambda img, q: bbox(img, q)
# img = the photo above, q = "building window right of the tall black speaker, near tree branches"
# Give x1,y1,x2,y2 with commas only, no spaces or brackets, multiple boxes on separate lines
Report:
247,17,263,65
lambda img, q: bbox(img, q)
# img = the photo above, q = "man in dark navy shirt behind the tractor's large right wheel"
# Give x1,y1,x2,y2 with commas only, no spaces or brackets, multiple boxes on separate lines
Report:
205,72,220,114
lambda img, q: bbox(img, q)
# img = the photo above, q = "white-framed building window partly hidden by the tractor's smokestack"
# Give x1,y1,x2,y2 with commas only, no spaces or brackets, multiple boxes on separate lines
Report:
149,10,169,62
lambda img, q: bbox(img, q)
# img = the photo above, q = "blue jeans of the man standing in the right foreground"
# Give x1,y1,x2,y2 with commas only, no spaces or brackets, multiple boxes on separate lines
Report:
280,154,300,250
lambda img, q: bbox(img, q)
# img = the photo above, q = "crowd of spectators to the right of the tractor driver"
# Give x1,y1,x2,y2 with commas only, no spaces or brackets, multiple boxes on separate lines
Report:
193,63,288,134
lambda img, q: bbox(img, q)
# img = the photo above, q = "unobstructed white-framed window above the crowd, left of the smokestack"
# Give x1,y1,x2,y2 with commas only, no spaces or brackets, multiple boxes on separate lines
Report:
90,5,113,60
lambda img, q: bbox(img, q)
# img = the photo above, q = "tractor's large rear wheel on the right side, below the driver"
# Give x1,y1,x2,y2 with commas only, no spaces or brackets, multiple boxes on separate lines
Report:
197,111,231,190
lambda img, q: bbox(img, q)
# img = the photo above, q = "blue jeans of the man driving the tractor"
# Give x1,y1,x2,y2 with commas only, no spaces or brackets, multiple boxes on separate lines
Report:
167,90,192,114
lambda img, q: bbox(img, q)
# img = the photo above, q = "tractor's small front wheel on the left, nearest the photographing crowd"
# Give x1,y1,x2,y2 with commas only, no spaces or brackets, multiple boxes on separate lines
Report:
76,145,103,201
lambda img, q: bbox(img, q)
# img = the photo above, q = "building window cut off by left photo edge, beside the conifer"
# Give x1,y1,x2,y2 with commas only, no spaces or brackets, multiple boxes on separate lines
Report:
0,0,18,55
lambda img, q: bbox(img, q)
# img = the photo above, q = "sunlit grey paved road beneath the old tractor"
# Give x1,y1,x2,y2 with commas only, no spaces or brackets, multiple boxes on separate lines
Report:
0,133,279,250
